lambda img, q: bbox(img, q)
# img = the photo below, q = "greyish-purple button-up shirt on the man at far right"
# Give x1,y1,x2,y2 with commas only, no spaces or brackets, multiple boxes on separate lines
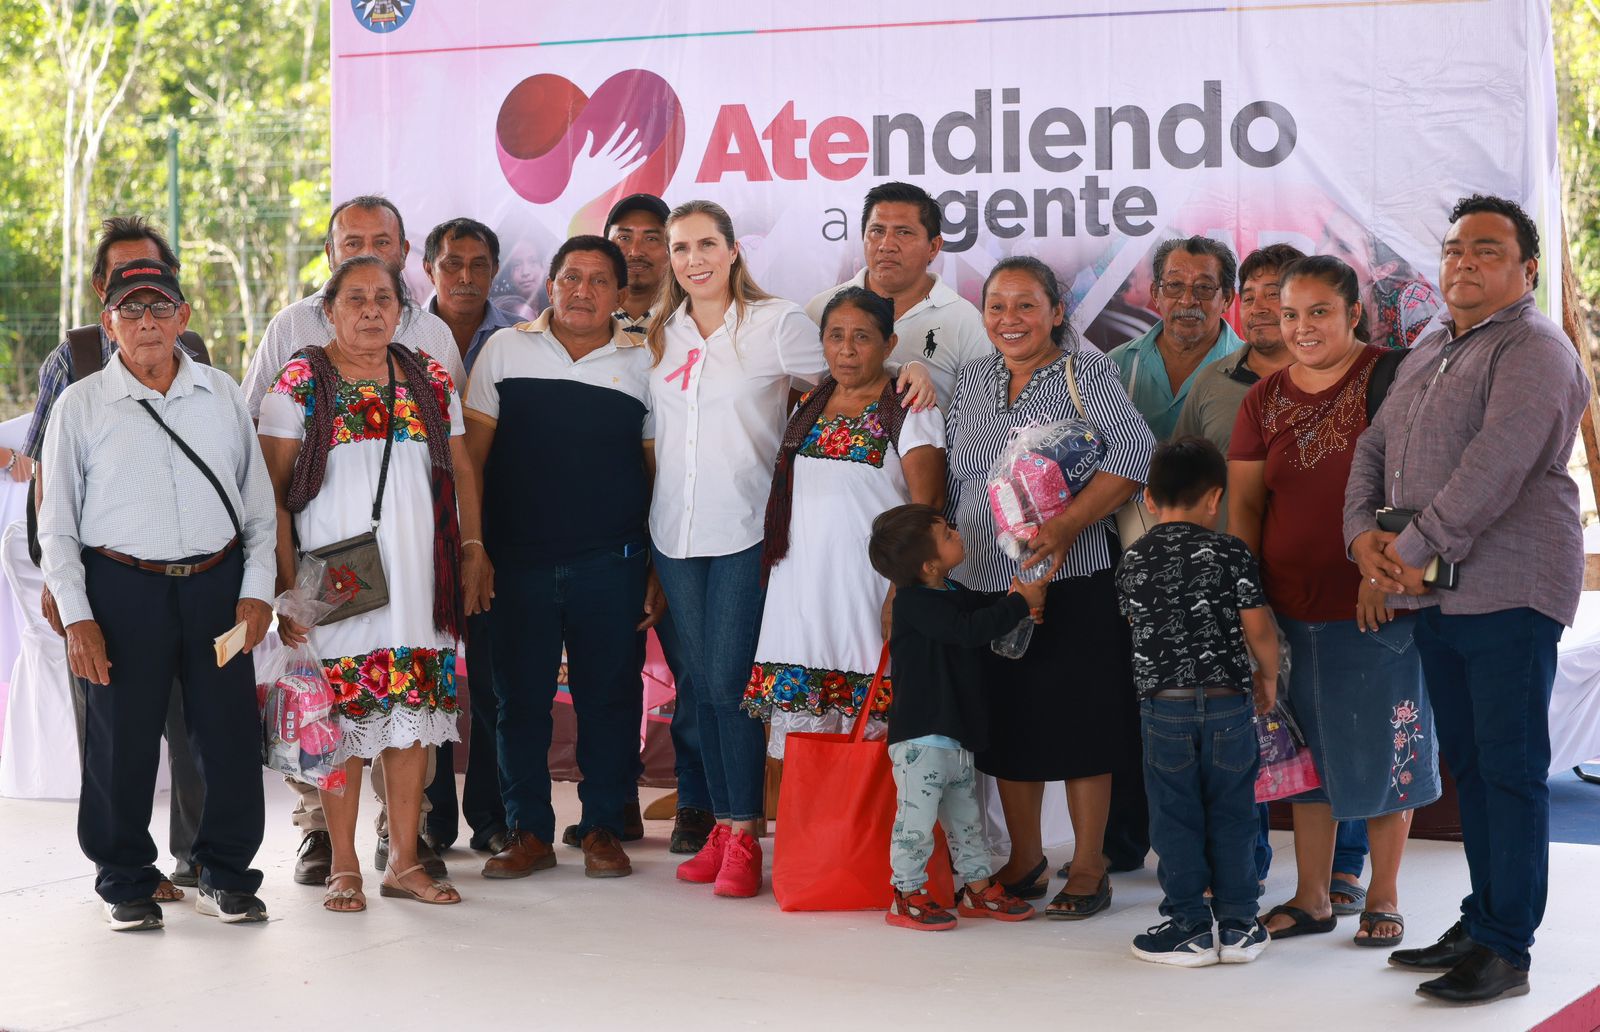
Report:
1344,294,1589,626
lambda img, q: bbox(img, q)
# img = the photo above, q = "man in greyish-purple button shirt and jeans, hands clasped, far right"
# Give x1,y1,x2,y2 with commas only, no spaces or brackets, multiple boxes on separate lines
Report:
1344,195,1589,1003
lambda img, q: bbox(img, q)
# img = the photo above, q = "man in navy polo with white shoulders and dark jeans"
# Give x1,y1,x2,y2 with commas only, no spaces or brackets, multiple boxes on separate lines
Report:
466,237,662,878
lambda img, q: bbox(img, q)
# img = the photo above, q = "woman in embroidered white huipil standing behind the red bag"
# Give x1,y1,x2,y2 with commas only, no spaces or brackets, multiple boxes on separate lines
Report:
744,286,944,760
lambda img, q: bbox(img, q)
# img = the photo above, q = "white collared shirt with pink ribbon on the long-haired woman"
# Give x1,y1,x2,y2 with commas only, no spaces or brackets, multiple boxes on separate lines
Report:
650,298,827,558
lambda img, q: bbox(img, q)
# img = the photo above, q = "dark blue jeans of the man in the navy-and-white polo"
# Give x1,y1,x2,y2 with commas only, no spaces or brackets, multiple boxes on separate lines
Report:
490,542,648,843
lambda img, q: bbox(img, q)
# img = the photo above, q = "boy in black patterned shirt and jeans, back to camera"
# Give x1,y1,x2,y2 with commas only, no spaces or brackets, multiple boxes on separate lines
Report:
1117,437,1278,968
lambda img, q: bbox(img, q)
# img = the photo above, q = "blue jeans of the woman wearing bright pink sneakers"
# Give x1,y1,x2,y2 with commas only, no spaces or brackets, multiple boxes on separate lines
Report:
656,544,766,821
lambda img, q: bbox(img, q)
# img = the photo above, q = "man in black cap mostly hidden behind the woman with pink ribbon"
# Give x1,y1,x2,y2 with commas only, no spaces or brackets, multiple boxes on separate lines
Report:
601,194,715,854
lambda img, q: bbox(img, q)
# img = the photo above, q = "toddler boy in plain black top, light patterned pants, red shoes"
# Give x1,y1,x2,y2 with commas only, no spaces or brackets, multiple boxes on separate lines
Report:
867,506,1046,931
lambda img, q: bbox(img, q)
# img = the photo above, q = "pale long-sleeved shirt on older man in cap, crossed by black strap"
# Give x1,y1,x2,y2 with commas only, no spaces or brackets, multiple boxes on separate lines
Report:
38,345,277,624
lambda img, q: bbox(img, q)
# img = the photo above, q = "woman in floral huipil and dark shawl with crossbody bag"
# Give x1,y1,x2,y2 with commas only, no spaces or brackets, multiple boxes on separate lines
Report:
258,256,486,912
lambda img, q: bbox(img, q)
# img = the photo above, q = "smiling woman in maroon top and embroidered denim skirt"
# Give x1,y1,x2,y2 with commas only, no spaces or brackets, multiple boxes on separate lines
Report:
1227,254,1440,947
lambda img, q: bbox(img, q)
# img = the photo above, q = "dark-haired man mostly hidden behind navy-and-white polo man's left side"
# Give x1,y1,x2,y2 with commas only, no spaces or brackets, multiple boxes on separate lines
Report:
422,218,517,854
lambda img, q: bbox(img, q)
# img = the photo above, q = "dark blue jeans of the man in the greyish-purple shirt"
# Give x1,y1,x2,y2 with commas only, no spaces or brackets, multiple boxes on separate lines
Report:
1416,606,1562,971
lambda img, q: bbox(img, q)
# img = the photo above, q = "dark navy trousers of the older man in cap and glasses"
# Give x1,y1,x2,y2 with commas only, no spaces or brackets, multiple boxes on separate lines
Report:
78,549,266,902
